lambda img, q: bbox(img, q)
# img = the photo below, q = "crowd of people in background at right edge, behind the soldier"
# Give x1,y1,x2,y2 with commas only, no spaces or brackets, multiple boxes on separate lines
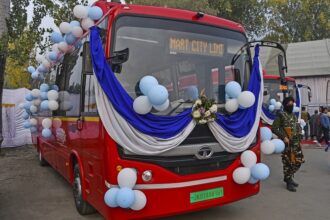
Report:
301,106,330,151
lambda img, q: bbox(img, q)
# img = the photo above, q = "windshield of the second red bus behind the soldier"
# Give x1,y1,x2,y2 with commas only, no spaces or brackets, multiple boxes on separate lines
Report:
263,79,296,106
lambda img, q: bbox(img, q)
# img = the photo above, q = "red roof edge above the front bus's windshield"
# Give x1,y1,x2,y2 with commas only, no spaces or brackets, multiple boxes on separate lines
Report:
95,1,245,34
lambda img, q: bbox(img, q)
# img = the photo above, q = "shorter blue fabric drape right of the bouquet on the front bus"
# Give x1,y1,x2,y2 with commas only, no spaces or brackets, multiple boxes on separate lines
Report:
216,45,261,137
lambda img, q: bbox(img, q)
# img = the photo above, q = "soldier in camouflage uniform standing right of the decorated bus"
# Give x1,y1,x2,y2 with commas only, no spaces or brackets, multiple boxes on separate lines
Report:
272,97,304,192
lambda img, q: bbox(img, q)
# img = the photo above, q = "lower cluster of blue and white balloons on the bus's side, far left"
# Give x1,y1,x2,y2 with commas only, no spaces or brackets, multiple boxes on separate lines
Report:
20,83,59,138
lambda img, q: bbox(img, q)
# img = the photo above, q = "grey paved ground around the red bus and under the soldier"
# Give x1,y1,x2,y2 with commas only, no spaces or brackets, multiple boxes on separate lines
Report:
0,146,330,220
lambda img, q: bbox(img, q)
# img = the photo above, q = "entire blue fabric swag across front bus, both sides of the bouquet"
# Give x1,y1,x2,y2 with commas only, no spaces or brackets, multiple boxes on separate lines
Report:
90,27,261,139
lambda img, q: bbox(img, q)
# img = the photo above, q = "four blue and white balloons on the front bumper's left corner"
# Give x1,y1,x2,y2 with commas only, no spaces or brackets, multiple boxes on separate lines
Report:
104,168,147,211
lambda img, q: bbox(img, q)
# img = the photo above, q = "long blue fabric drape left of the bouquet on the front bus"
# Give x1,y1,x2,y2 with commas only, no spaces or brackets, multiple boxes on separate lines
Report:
90,27,192,139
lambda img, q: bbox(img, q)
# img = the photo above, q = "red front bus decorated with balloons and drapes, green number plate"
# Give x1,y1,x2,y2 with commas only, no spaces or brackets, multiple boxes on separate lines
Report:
33,1,260,219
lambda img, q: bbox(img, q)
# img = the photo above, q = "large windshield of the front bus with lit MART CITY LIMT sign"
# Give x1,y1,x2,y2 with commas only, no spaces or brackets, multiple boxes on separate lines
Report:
110,16,249,115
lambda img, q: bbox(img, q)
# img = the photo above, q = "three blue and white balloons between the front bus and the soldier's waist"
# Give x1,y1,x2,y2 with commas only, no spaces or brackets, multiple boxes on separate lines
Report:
260,127,285,155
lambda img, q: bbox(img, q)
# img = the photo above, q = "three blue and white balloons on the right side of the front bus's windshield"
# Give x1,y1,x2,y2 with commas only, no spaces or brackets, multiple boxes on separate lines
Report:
225,81,256,113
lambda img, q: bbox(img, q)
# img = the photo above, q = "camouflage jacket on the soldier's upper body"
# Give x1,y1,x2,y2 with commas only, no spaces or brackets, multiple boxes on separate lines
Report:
272,111,301,141
